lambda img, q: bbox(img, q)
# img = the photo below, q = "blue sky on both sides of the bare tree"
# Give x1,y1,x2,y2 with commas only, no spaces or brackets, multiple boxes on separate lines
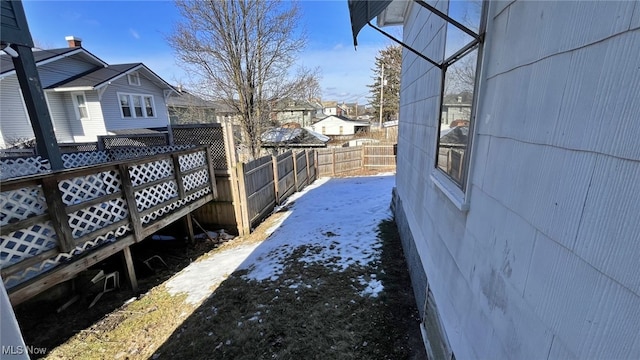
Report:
23,0,397,104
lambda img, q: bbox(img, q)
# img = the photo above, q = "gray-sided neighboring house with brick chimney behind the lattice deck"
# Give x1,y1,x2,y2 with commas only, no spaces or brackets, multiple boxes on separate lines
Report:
0,37,174,147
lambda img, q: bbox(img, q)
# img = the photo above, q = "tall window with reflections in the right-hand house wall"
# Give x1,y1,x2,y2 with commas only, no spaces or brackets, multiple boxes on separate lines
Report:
436,1,484,191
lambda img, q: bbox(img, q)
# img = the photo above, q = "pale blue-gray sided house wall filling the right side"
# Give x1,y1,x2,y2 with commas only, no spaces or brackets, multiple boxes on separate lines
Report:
394,0,640,359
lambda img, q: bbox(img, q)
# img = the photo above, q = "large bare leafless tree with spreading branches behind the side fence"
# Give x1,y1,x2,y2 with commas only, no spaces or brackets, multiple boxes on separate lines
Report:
168,0,317,157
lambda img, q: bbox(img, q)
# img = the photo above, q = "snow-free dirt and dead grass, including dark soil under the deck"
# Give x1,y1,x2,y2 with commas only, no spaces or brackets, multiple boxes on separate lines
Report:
16,173,427,360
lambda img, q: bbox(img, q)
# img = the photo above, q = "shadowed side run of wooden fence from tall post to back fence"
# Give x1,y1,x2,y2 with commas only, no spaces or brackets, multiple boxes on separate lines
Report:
236,150,317,235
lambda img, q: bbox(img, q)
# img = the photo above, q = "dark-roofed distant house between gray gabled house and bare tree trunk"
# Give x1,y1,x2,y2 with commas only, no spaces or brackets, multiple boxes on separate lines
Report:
167,86,218,124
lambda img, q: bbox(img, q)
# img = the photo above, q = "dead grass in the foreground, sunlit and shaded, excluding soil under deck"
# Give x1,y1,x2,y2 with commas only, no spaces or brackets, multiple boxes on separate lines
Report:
35,214,426,360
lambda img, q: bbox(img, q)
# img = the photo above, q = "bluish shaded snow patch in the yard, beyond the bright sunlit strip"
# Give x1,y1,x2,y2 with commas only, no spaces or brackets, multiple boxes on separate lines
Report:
240,175,395,281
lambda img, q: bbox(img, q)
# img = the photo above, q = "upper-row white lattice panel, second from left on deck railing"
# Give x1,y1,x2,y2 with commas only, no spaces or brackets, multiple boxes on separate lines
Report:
58,171,121,205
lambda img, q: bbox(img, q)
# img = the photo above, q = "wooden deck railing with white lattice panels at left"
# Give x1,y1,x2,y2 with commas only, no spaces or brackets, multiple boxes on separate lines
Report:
0,147,217,290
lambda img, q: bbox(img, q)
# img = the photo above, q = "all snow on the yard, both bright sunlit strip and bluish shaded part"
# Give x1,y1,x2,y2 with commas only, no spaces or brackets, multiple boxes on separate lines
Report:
166,174,395,304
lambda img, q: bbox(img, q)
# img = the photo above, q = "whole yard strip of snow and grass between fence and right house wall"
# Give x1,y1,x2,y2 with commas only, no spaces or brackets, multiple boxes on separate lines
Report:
43,174,424,359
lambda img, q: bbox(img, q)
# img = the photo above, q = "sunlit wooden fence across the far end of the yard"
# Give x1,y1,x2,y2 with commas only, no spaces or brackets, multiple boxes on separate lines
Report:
317,145,396,176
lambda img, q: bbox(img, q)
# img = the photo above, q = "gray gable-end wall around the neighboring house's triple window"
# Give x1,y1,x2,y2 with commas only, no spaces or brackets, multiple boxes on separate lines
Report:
102,71,169,130
